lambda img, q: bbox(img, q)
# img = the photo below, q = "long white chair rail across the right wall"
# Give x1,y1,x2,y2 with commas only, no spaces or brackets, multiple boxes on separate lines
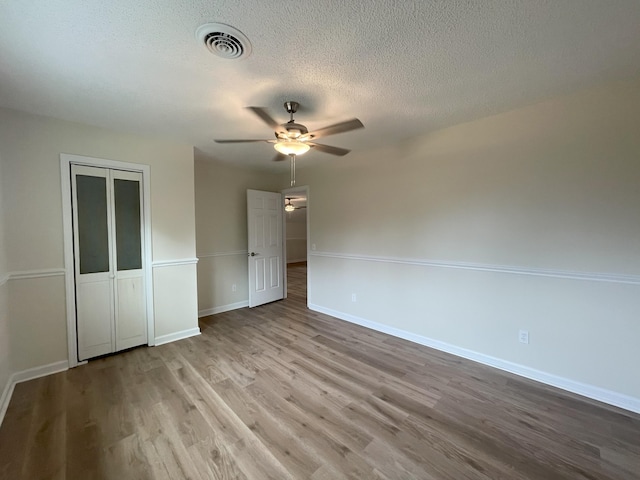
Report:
309,251,640,285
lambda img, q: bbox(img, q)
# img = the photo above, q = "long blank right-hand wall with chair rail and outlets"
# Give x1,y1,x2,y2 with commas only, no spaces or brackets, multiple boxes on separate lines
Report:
298,82,640,409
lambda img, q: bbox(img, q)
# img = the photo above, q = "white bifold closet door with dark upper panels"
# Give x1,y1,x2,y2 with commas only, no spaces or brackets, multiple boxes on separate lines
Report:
71,165,147,360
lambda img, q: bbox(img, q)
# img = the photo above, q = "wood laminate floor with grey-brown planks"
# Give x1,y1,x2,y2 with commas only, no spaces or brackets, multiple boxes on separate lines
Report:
0,265,640,480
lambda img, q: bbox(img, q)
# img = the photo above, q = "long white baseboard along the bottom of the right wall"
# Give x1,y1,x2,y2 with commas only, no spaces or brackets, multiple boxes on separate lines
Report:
309,304,640,413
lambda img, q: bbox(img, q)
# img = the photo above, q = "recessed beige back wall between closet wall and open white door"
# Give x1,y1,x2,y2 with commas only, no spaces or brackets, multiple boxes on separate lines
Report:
195,152,288,316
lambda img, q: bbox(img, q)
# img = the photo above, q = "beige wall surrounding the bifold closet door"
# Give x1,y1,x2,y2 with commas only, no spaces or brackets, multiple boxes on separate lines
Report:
0,109,197,371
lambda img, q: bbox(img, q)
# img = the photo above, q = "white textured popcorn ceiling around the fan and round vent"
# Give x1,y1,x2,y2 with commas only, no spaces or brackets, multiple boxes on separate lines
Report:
0,0,640,170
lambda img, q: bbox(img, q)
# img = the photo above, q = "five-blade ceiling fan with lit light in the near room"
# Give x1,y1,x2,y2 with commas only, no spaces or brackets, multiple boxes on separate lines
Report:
215,101,364,161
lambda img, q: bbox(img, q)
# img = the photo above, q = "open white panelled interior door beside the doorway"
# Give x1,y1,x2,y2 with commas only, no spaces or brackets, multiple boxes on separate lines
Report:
247,190,284,307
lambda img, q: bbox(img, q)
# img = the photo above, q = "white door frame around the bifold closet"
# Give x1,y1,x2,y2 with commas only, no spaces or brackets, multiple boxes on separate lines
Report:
60,153,155,368
